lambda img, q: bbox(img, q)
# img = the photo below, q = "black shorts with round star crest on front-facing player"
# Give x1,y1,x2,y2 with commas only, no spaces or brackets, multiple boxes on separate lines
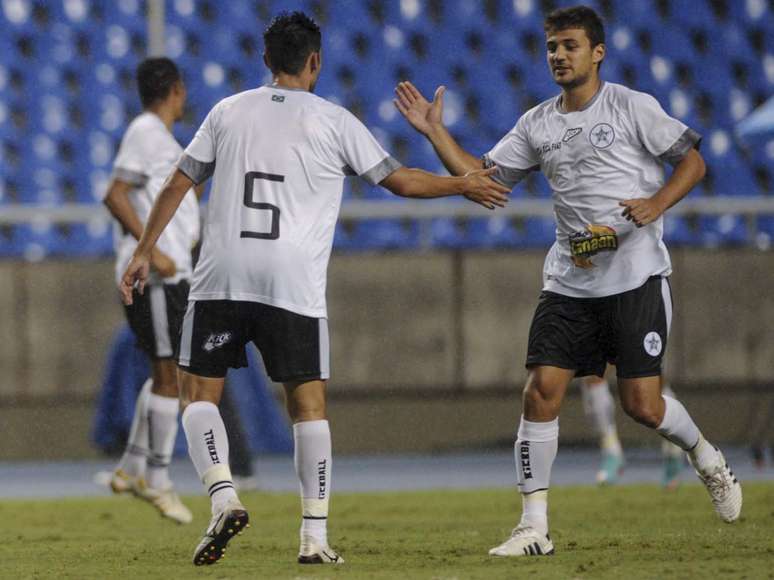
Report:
527,276,672,379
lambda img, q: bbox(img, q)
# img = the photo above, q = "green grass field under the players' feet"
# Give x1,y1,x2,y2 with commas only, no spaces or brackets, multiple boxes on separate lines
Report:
0,483,774,580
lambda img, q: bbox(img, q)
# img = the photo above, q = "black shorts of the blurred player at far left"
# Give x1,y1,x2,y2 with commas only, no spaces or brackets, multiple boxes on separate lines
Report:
124,280,189,360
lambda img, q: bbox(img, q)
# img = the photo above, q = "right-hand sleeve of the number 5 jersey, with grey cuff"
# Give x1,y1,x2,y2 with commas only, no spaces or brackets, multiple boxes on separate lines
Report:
338,109,401,185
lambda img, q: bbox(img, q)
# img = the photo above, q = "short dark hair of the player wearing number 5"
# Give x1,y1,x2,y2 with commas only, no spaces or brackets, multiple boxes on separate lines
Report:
263,11,322,75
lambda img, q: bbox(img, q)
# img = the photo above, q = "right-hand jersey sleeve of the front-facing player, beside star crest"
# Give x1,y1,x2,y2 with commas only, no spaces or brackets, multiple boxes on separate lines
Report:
630,93,701,165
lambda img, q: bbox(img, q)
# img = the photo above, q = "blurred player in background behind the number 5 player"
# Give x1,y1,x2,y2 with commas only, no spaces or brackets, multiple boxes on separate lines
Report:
104,58,200,524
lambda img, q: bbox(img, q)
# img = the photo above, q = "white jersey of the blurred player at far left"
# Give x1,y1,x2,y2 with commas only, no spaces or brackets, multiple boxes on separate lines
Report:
107,111,200,284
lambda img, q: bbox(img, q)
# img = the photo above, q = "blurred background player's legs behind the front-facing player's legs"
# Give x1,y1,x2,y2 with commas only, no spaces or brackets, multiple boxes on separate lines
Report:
581,375,684,489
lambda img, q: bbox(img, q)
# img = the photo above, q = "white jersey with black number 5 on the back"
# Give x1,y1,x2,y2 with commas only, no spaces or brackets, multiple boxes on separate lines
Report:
178,86,400,318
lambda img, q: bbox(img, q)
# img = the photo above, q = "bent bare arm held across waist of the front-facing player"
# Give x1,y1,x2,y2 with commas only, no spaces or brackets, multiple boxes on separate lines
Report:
621,149,706,228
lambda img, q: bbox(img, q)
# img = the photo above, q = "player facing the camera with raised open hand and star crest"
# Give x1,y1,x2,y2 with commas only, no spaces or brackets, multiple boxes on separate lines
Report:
396,6,742,556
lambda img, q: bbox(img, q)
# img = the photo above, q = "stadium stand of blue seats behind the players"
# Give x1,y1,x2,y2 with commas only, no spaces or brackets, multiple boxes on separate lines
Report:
0,0,774,260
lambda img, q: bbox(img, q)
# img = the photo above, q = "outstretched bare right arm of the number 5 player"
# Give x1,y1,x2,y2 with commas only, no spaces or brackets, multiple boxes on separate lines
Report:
379,167,510,209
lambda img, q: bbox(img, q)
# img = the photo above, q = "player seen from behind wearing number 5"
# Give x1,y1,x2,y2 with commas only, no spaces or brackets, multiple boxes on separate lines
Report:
121,12,509,565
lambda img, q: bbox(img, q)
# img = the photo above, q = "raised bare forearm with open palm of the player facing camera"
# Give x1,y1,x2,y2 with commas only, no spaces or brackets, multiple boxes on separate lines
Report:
394,81,483,175
